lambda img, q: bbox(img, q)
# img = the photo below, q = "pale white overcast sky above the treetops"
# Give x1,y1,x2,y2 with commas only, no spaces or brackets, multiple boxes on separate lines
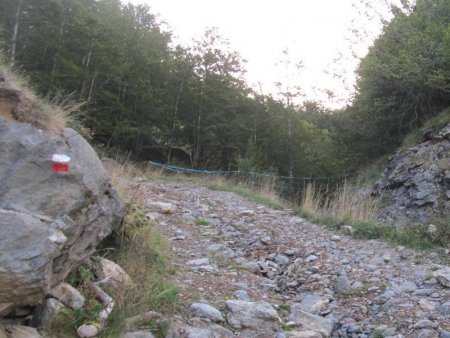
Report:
124,0,394,107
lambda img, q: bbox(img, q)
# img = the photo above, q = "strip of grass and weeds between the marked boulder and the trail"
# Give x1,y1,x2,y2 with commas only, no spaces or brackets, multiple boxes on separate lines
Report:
46,160,180,337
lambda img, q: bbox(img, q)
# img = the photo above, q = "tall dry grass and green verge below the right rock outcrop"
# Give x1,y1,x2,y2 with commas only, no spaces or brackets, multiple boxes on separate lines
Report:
298,182,450,249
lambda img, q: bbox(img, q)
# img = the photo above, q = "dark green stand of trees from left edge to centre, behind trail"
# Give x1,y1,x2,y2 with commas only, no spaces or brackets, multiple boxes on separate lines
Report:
0,0,340,182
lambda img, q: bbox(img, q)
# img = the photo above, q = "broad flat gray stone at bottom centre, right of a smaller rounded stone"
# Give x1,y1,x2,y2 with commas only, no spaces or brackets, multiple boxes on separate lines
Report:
225,300,279,331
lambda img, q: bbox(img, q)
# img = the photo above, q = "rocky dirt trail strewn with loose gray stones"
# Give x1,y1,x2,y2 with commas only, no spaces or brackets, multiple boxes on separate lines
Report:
137,182,450,338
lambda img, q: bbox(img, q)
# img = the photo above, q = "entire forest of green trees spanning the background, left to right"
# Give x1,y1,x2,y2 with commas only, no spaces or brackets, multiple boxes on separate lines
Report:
0,0,450,182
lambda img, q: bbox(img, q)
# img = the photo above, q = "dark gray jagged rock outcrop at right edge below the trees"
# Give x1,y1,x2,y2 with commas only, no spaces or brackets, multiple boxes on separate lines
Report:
373,124,450,224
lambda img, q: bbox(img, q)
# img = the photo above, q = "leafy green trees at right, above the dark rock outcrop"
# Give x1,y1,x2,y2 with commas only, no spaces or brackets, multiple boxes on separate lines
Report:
334,0,450,166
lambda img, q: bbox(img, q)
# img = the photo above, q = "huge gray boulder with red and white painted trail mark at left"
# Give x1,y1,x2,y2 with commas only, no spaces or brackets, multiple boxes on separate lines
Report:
0,74,123,306
